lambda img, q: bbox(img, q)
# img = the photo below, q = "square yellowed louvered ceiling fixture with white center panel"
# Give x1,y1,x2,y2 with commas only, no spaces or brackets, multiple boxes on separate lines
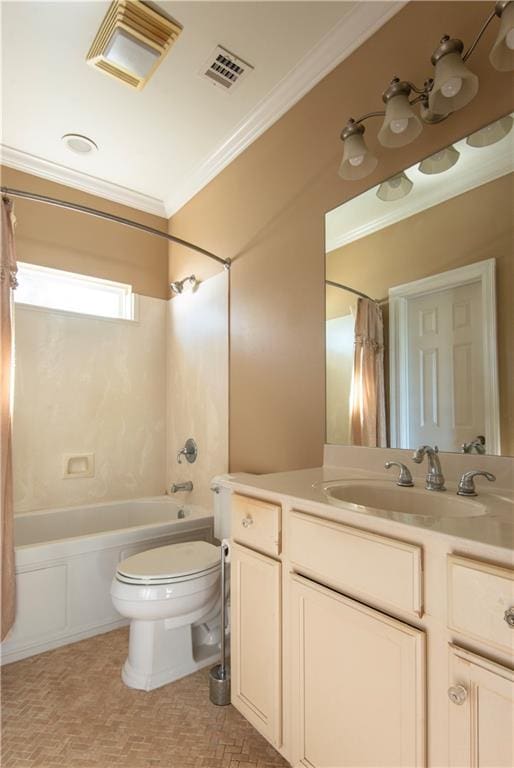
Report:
86,0,182,90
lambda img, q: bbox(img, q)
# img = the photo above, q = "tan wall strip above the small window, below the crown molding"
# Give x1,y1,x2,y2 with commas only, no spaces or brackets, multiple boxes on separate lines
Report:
0,166,168,299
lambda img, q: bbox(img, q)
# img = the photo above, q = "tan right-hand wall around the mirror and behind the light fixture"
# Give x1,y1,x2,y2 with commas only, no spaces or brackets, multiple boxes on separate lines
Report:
170,2,514,472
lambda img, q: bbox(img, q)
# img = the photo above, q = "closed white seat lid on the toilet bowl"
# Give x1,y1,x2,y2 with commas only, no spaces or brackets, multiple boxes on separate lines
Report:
117,541,221,579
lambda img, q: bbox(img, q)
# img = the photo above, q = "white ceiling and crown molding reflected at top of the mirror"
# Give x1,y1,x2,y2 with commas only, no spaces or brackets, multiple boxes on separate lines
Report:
325,113,514,253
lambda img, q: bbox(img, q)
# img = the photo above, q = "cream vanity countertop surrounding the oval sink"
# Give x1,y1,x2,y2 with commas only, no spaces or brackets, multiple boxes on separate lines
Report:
220,466,514,552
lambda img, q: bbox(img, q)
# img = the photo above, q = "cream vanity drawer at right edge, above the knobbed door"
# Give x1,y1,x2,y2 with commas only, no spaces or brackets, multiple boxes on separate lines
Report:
448,555,514,655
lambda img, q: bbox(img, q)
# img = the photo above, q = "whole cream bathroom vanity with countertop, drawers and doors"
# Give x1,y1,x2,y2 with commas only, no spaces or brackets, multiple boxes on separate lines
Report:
226,449,514,768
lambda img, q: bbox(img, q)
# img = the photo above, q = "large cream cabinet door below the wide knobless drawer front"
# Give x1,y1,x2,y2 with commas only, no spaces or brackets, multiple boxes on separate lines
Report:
290,576,425,768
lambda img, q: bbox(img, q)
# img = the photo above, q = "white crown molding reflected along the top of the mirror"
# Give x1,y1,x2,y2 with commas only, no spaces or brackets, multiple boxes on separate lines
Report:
326,144,514,253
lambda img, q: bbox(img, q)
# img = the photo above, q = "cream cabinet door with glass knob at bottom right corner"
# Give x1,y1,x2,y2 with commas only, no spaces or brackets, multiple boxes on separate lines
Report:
448,646,514,768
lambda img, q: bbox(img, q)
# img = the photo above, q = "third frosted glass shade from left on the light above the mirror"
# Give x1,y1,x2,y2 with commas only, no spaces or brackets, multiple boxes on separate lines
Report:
428,53,478,115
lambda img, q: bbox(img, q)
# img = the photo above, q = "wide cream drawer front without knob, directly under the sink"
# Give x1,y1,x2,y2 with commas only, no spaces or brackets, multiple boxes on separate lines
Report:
288,510,423,616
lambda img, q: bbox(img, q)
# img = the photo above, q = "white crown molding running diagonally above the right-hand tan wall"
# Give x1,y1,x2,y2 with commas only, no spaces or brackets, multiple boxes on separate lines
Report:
165,0,407,216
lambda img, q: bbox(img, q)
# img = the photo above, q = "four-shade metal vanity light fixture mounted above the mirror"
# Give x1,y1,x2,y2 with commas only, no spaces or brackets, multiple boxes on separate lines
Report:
339,0,514,180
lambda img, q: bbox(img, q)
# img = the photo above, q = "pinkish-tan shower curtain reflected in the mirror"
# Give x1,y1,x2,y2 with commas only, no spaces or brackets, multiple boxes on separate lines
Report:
350,299,386,448
